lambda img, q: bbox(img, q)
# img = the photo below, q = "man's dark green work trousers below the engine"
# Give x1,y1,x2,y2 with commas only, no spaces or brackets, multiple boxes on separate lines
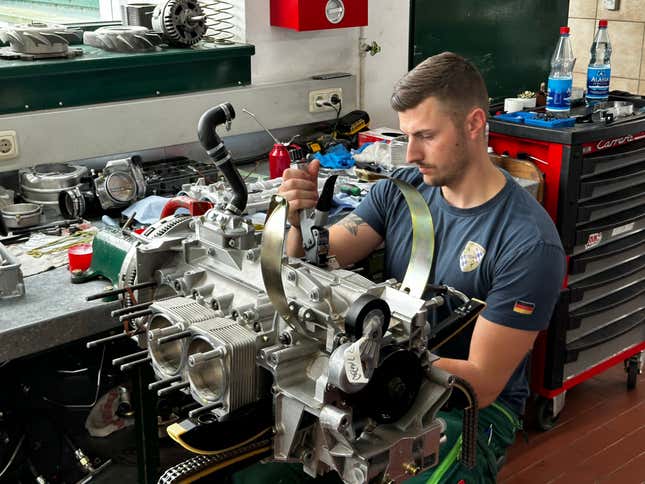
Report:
233,402,521,484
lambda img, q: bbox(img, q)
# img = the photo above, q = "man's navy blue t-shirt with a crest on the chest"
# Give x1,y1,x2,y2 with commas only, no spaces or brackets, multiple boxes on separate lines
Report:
354,168,565,414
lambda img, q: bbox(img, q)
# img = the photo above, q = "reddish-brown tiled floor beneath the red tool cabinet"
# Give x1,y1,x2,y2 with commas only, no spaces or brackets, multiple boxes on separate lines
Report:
499,365,645,484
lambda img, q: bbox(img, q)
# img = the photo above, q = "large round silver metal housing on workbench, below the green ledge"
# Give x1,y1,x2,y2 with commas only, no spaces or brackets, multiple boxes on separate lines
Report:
18,163,88,212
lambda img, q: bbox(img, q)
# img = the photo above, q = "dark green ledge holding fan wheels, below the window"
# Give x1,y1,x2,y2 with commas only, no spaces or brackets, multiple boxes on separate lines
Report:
0,44,255,114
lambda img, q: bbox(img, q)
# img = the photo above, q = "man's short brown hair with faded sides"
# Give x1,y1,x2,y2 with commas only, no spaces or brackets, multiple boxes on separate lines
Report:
390,52,488,123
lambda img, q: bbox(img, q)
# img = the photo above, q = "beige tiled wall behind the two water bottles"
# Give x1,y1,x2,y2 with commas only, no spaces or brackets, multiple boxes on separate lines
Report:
569,0,645,95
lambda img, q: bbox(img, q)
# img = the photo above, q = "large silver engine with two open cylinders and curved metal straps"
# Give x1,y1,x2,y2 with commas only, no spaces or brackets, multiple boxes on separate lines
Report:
83,104,475,483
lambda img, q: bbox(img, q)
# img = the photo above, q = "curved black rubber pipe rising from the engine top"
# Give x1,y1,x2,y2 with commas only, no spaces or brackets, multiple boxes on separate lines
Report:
197,103,248,215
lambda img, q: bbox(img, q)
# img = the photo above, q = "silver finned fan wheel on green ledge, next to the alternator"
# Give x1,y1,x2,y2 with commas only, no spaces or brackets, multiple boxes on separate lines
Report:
83,25,162,52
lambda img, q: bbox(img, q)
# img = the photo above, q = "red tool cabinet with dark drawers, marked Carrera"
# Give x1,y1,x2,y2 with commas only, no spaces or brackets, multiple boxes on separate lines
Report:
489,97,645,430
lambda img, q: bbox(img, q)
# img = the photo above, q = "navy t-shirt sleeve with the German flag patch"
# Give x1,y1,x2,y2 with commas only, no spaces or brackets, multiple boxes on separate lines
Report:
482,242,566,331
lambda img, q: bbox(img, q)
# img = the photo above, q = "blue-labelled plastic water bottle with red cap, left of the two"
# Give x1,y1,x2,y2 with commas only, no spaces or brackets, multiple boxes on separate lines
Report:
546,27,576,118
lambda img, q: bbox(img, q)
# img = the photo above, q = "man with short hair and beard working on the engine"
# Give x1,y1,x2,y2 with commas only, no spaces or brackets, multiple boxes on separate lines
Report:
238,52,565,484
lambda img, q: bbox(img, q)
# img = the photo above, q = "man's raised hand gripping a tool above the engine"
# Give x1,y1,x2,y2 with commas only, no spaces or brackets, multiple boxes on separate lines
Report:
278,160,320,227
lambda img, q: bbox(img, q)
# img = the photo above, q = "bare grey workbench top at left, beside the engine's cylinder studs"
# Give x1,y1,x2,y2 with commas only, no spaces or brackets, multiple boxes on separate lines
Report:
0,267,119,362
